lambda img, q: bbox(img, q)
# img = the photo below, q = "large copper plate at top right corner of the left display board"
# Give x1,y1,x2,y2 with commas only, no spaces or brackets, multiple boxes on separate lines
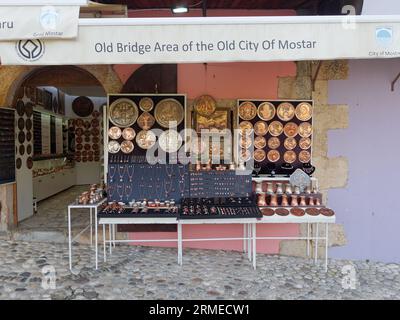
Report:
154,98,185,128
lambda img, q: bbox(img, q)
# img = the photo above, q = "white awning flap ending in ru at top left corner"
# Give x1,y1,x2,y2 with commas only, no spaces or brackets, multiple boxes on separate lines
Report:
0,6,79,40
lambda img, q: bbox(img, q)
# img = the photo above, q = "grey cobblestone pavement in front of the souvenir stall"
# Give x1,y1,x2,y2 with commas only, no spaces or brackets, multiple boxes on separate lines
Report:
0,241,400,300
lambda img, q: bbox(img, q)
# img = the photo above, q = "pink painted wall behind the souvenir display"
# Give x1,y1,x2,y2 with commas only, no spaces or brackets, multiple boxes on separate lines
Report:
114,10,299,253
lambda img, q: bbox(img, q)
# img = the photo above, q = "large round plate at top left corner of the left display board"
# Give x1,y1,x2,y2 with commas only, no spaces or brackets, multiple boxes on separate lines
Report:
109,98,139,128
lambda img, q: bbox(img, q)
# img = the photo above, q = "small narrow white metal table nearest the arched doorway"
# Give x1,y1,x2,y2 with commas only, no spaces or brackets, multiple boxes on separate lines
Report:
68,198,107,270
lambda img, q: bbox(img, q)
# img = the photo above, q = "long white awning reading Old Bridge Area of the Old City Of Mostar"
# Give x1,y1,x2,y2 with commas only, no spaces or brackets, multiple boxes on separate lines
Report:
0,16,400,65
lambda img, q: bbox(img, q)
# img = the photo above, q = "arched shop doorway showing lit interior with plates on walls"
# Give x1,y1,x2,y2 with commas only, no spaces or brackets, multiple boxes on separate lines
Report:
13,66,107,240
